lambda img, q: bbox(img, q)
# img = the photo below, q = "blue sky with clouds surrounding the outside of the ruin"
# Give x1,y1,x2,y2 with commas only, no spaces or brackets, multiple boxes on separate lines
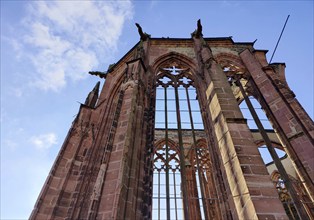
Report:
0,0,314,219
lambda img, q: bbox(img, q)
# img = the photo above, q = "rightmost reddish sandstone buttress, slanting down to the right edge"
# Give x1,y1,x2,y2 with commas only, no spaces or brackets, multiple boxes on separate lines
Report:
240,50,314,201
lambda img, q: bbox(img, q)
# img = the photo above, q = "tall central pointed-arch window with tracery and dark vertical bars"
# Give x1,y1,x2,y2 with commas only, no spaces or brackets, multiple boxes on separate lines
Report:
152,63,217,219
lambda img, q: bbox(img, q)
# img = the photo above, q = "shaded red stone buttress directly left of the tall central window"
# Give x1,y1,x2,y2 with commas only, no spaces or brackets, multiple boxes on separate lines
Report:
97,59,147,220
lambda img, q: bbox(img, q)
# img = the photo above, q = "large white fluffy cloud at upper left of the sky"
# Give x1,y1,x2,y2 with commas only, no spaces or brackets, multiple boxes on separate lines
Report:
19,1,133,91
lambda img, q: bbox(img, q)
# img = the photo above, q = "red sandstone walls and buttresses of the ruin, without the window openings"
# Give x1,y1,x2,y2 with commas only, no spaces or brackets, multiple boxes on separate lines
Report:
30,23,314,220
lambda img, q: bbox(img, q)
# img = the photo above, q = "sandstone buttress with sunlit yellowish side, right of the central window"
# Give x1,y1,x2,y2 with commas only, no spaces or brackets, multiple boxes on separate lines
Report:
194,37,288,219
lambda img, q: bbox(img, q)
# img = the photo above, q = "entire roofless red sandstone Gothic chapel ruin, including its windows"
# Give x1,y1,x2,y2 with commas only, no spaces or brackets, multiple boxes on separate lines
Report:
30,20,314,220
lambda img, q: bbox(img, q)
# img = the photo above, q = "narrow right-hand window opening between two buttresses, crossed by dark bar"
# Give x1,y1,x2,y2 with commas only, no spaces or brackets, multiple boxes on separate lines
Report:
234,80,306,220
